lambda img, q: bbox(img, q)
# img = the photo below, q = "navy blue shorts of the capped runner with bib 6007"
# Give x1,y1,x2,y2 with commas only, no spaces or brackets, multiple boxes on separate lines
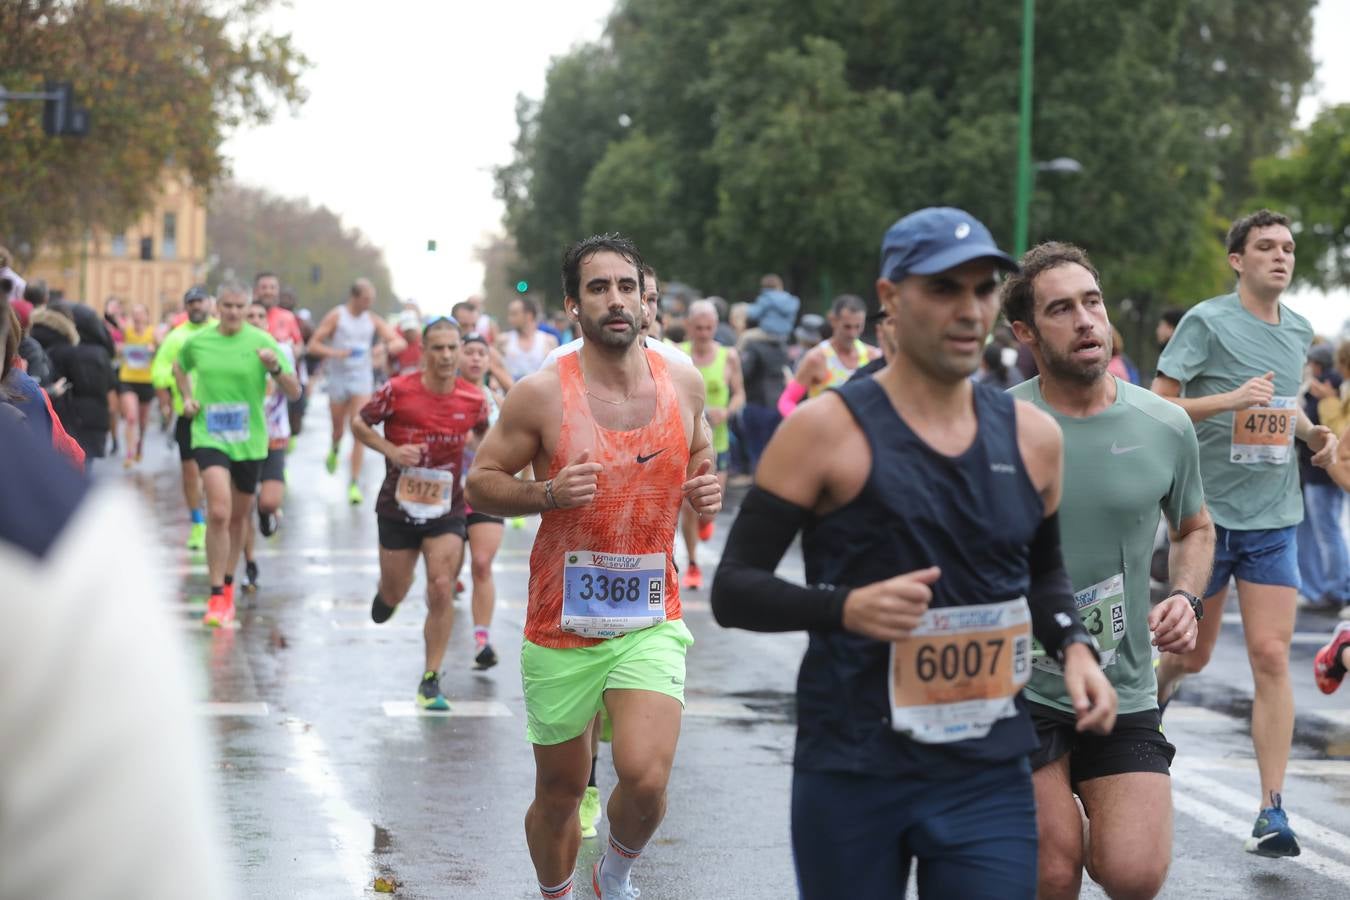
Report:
792,757,1037,900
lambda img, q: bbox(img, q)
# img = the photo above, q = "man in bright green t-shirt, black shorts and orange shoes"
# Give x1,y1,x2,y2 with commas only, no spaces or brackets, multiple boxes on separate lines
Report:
174,283,300,626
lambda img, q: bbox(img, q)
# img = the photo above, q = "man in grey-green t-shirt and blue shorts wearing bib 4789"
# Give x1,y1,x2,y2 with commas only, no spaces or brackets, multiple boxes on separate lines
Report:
1153,209,1337,857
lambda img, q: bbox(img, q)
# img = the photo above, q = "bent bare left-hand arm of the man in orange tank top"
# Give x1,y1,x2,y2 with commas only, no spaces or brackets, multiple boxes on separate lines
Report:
464,375,562,515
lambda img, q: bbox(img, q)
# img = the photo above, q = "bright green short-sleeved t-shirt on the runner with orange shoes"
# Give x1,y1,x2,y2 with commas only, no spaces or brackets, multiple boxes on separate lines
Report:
178,325,296,461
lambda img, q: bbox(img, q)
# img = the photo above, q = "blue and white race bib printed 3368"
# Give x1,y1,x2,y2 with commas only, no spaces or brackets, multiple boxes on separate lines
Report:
562,551,666,638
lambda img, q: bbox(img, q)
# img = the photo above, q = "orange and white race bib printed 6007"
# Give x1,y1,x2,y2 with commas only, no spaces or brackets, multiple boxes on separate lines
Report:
890,598,1031,743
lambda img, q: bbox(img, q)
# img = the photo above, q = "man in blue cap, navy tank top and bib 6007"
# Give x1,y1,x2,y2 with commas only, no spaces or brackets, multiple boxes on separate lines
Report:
713,208,1115,900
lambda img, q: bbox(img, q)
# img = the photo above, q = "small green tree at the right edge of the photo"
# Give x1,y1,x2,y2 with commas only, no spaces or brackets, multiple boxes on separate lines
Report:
1253,104,1350,289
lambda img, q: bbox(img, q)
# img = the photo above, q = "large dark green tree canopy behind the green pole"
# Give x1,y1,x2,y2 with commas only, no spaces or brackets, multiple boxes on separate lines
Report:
497,0,1315,341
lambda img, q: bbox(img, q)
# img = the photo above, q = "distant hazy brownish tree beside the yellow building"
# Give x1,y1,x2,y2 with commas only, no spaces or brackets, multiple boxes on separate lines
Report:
207,182,398,314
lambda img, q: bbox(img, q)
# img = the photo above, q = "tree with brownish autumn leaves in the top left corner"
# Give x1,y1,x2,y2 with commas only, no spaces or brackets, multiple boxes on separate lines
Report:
0,0,308,264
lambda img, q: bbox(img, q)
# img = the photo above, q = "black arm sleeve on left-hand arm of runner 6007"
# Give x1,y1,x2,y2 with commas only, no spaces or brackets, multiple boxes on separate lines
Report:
713,487,848,631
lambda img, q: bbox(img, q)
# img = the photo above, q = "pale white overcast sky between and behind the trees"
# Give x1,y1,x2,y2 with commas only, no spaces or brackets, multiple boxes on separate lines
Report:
225,0,1350,322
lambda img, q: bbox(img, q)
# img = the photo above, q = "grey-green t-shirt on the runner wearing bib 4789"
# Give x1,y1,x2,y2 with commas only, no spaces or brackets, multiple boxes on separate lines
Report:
1158,294,1312,530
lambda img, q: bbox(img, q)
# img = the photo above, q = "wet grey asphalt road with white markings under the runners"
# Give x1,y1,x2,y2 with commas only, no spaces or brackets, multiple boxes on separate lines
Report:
110,395,1350,900
